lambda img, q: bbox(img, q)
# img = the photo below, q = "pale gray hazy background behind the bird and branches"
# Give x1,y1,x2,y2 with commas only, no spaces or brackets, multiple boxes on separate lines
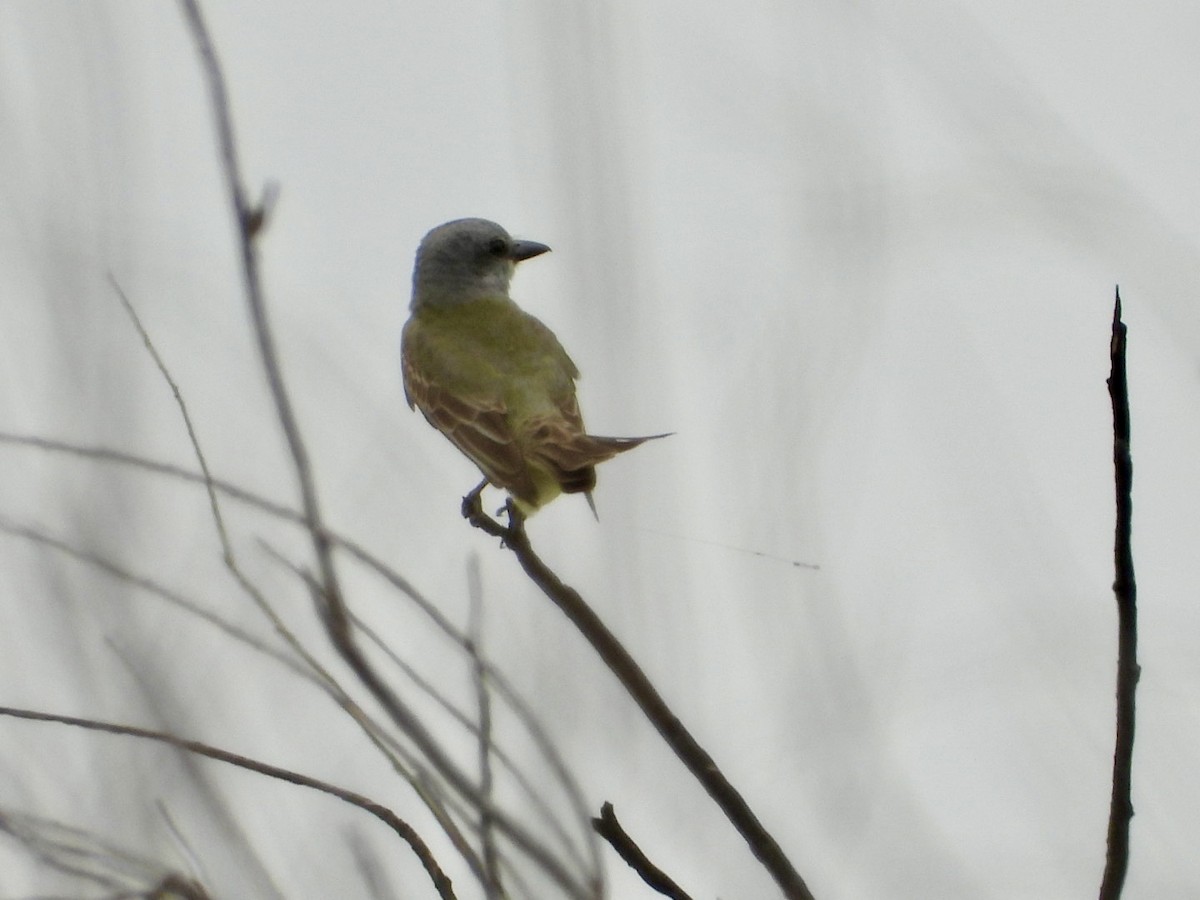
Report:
0,0,1200,900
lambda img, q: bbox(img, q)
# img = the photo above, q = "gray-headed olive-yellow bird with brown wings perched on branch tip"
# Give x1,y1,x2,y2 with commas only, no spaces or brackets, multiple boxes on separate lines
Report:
401,218,667,518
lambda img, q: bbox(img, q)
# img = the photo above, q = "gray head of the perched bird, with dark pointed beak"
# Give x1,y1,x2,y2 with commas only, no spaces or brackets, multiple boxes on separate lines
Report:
410,218,550,310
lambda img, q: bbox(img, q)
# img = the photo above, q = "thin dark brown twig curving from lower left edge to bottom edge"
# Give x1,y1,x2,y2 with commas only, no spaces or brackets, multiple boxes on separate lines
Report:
0,707,455,900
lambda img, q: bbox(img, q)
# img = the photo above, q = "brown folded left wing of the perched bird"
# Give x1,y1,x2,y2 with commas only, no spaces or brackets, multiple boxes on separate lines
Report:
401,319,538,502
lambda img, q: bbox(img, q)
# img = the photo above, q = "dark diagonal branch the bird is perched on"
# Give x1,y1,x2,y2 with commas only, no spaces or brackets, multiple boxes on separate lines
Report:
462,492,812,900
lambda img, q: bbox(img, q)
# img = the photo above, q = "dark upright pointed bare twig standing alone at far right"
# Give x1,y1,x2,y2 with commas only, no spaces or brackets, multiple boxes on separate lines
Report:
1100,288,1141,900
